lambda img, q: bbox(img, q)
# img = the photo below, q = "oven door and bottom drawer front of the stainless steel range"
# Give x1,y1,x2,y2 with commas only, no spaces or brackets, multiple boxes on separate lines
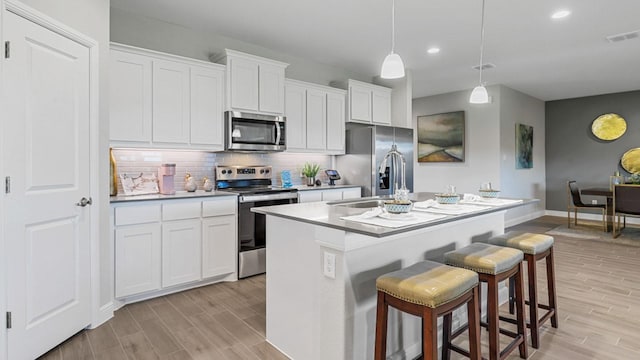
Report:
238,198,298,279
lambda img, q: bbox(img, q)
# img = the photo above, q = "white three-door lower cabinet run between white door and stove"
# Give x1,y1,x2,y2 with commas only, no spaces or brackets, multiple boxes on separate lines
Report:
114,196,238,302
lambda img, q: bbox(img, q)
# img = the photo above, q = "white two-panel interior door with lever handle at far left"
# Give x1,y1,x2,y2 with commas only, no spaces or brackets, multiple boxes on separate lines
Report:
2,12,91,359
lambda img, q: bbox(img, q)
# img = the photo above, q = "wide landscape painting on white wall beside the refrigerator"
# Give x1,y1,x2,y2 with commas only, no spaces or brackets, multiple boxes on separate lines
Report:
417,111,465,163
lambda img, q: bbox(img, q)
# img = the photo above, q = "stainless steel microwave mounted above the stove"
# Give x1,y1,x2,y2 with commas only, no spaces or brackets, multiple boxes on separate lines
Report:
225,111,287,152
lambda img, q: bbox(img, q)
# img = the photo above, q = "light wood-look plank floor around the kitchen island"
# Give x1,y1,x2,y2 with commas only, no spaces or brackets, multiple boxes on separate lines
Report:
37,217,640,360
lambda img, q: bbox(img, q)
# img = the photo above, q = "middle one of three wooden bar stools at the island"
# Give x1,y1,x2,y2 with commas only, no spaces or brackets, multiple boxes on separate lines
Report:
444,243,528,360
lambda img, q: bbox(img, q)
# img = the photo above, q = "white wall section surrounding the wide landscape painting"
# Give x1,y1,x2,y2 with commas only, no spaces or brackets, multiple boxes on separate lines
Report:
412,86,501,193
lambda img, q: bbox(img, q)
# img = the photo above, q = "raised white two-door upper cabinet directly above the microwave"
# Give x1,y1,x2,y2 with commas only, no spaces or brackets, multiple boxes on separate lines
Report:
217,49,289,115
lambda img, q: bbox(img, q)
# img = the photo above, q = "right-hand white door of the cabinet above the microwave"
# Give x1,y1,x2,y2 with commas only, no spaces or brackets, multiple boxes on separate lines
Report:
258,64,284,114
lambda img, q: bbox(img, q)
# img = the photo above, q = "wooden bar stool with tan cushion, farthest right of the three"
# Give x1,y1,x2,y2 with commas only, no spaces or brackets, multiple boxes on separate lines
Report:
489,231,558,349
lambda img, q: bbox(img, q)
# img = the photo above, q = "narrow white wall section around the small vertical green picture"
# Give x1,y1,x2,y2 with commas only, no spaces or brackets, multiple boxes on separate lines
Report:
500,86,546,224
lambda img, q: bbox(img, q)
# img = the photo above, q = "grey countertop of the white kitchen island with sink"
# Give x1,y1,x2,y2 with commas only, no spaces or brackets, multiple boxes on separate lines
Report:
251,192,539,237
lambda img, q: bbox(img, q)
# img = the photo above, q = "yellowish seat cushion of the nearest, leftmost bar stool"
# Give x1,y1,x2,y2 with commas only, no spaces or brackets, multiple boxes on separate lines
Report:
376,261,478,308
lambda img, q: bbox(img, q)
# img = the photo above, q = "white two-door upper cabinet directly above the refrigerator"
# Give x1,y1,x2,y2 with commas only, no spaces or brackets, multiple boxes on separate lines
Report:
342,80,391,125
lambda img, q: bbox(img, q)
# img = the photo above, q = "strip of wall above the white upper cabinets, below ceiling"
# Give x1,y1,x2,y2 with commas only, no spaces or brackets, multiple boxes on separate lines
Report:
111,8,372,85
